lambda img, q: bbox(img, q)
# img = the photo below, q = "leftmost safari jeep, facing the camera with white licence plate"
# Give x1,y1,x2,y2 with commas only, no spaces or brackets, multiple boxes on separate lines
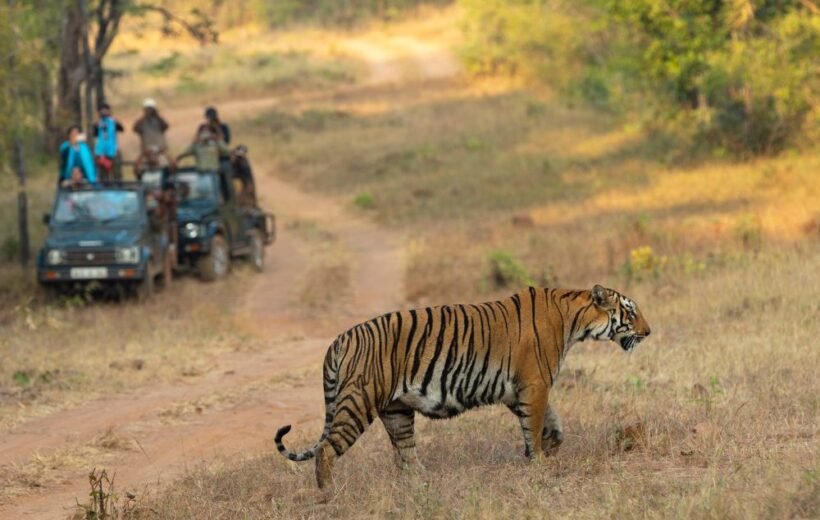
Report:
37,183,172,299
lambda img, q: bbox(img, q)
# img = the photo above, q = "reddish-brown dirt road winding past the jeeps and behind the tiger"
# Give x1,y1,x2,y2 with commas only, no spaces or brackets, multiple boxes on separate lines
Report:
0,34,456,519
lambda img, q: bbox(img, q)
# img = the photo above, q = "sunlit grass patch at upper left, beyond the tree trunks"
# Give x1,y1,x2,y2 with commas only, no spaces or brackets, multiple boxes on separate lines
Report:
108,22,358,106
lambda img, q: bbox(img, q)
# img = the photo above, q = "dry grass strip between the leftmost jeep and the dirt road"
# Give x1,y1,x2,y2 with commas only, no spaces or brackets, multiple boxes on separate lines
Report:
0,273,257,429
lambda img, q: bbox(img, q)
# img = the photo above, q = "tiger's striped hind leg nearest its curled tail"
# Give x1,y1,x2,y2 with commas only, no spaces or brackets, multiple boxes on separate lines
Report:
316,384,375,489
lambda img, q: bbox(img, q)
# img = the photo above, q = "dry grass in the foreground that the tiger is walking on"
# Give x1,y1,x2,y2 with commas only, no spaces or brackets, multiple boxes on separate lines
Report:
138,249,820,518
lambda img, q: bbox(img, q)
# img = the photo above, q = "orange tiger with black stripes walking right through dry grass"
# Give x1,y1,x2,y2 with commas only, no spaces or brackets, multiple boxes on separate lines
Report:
275,285,650,489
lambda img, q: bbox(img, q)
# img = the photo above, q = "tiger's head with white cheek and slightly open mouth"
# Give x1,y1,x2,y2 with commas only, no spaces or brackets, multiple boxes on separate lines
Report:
587,285,652,352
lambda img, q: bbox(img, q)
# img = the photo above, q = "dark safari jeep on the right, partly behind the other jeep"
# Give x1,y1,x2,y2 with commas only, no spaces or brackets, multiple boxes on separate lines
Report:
173,168,276,281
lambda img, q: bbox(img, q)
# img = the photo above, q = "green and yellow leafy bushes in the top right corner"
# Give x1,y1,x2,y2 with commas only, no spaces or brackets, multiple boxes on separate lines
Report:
460,0,820,156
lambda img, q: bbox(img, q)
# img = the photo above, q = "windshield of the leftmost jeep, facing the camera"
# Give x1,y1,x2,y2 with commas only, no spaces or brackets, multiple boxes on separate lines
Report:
52,190,141,224
